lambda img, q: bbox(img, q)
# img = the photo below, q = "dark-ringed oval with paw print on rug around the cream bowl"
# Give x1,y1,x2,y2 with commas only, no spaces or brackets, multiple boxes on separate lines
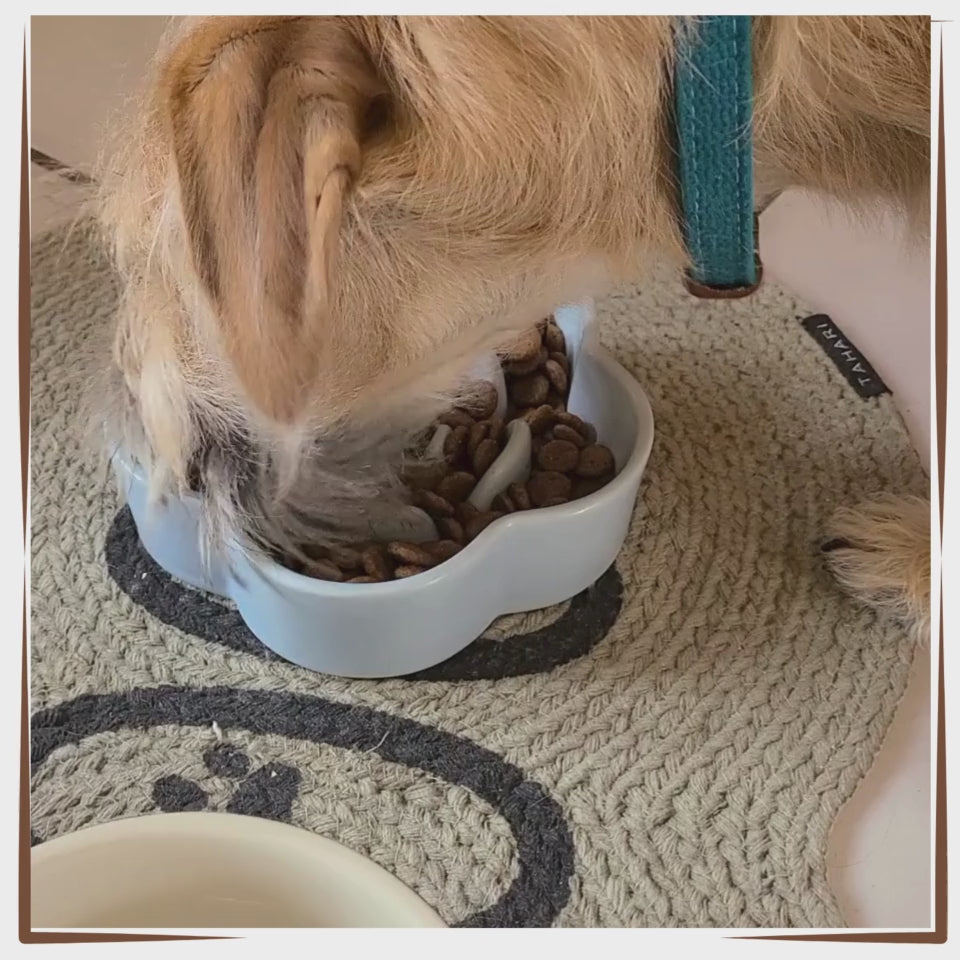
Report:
30,687,576,927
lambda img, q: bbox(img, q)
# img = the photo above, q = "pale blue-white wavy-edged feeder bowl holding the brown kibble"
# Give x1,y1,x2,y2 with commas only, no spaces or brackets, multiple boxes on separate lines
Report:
115,303,653,677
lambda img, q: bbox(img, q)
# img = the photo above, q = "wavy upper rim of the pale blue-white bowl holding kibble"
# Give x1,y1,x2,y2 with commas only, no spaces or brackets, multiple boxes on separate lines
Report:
115,340,655,600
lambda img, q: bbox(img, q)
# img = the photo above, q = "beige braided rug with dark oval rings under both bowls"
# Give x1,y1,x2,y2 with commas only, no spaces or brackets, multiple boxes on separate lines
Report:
31,221,926,927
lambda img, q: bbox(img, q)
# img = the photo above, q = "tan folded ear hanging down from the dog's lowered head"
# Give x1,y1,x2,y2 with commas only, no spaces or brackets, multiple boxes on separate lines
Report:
161,17,384,424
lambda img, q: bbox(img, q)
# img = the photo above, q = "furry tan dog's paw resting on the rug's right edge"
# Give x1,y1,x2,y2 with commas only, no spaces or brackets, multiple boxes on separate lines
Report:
821,494,930,642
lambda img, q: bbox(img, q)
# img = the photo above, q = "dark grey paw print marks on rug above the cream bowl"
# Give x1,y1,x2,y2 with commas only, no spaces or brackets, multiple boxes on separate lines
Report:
153,743,300,821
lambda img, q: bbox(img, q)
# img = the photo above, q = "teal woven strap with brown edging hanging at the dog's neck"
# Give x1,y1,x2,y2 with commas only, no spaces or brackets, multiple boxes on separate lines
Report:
674,16,761,297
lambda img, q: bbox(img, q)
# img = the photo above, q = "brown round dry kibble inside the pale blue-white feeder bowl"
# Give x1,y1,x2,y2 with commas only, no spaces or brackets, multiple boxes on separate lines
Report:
289,318,615,583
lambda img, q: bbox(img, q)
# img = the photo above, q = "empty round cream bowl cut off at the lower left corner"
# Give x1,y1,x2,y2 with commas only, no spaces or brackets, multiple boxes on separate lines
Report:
30,813,444,930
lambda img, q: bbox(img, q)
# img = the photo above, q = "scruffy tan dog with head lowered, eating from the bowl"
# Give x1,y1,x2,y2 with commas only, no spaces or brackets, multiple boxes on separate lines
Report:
95,17,930,628
